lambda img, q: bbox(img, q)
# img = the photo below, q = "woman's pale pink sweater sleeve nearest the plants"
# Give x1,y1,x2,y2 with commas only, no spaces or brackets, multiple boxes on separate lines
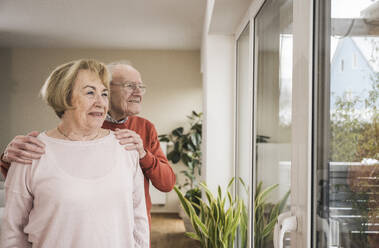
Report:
133,154,150,248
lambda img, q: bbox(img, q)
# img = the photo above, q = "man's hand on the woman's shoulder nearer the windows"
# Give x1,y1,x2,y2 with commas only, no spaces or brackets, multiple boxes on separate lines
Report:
115,128,146,159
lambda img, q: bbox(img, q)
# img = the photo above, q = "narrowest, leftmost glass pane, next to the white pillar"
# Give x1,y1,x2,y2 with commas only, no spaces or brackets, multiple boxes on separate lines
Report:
236,24,252,247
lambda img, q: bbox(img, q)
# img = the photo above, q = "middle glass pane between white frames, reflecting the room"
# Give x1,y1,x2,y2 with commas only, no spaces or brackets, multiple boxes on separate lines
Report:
254,0,293,248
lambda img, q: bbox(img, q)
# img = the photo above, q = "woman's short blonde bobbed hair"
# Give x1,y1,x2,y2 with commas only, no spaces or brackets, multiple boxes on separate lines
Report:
40,59,110,118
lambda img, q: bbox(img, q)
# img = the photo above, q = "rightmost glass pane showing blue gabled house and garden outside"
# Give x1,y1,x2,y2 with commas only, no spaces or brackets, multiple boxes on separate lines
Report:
316,0,379,248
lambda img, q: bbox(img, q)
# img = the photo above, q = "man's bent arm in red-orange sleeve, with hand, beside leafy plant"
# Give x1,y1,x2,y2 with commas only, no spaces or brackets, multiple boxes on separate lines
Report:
116,125,176,192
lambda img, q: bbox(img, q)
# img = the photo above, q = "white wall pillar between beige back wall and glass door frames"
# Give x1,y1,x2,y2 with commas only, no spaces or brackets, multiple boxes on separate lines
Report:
203,34,235,192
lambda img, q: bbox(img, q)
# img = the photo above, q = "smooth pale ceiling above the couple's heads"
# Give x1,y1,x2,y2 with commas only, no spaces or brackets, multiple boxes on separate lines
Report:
0,0,206,50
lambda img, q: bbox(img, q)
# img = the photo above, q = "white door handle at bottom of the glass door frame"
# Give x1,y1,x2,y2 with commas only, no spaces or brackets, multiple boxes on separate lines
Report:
274,212,297,248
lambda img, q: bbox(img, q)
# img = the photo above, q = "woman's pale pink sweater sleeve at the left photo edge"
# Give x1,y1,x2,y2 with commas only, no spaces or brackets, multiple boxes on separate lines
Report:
0,163,33,248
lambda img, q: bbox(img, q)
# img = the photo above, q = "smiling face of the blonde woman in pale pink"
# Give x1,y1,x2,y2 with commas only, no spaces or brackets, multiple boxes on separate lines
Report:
63,70,109,130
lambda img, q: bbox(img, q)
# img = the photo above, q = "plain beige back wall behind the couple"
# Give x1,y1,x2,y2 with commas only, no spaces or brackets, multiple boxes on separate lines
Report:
0,48,202,212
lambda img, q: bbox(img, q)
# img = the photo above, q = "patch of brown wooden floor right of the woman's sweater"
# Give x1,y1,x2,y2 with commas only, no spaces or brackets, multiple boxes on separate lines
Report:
151,213,200,248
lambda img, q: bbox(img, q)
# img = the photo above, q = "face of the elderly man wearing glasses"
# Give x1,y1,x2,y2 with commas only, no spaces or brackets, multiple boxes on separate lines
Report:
110,65,143,120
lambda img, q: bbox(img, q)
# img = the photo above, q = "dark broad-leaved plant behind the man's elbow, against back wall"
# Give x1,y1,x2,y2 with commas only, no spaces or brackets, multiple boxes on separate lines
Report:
159,111,203,223
